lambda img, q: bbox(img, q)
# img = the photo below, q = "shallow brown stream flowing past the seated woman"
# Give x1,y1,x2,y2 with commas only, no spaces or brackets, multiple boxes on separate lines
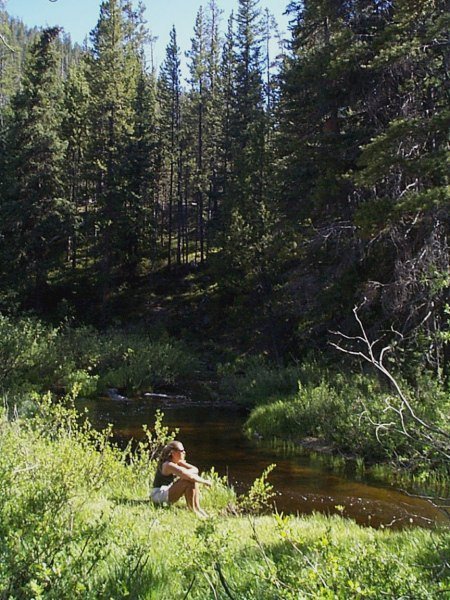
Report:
80,398,445,528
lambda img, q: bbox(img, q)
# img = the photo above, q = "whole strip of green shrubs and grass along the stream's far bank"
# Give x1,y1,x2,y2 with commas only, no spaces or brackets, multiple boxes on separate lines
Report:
0,315,450,478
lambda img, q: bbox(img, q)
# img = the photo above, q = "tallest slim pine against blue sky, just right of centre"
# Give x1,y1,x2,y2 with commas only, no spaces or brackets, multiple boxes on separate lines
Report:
216,0,276,296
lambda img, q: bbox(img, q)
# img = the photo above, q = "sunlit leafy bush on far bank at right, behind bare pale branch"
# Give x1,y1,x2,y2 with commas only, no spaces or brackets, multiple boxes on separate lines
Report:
246,360,450,465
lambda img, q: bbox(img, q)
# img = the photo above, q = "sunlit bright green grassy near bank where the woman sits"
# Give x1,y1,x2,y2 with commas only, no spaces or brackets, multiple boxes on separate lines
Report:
0,396,450,600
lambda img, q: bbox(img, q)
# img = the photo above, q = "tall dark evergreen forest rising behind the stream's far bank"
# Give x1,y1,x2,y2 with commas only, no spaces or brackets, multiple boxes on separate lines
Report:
0,0,449,379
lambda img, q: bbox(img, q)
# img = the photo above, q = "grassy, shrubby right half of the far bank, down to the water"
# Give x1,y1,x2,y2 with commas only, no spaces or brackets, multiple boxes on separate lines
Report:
221,358,450,484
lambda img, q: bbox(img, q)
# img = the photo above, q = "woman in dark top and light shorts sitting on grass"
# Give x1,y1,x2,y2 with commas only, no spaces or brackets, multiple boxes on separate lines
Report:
150,440,211,517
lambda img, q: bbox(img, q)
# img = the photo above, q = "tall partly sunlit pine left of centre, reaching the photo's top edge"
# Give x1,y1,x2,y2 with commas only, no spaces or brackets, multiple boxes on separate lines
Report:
87,0,141,308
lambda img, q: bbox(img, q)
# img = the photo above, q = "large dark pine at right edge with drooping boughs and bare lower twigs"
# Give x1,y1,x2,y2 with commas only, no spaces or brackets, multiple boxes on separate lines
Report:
353,0,450,376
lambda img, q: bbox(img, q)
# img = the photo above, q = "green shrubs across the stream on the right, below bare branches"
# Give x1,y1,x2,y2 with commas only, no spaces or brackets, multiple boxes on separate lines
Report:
236,361,448,470
